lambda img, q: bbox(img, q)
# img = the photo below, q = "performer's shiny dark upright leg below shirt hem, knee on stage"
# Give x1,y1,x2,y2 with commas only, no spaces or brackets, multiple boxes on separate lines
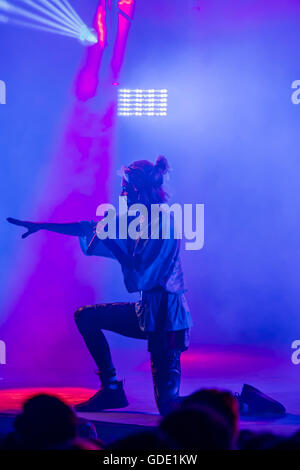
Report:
151,351,181,416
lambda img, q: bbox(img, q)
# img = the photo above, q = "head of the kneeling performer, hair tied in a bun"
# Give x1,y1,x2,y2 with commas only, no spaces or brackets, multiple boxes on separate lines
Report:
122,155,170,205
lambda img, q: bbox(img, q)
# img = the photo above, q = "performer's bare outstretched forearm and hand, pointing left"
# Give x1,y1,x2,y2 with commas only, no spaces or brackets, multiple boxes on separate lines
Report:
7,217,84,238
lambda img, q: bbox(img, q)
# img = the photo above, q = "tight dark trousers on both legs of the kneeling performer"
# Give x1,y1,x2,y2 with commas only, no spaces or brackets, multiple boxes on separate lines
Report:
75,302,181,414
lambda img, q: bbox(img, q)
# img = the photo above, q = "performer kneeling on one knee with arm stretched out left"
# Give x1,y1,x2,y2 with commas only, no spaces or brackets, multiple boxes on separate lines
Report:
7,157,191,414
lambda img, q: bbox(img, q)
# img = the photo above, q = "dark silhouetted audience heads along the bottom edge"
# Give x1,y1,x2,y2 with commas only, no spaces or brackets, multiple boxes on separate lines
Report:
0,389,300,451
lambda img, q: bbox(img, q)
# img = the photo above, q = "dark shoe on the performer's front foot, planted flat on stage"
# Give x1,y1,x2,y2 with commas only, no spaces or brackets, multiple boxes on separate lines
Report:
74,381,129,413
